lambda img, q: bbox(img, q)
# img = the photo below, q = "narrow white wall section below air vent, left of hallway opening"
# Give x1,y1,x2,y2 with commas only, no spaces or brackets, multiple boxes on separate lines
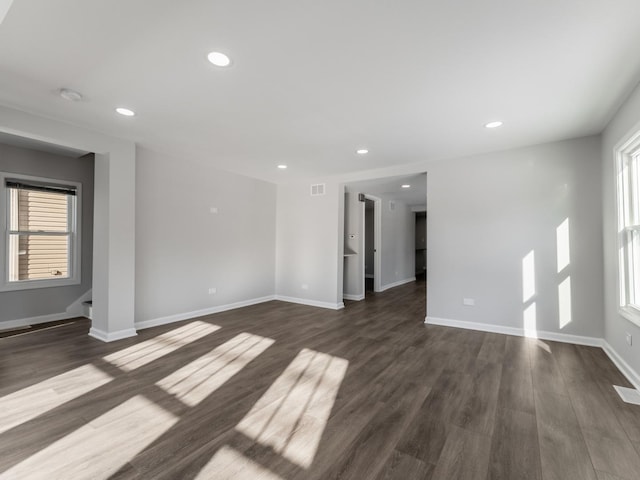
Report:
276,182,344,308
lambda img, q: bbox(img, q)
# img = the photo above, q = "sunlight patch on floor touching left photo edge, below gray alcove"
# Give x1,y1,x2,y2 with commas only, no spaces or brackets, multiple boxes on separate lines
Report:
0,365,112,433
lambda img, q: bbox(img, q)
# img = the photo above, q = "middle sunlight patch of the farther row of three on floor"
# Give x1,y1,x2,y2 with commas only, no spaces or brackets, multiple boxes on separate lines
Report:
156,333,274,407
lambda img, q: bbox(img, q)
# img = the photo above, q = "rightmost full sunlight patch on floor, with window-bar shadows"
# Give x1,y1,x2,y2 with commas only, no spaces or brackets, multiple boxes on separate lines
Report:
236,349,349,468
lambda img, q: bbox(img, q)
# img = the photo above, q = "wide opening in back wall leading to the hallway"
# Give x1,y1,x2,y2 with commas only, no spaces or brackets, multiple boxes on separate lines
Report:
341,173,427,316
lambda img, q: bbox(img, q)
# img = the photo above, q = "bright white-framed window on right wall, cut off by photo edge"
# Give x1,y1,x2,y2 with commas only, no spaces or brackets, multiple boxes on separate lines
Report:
614,130,640,326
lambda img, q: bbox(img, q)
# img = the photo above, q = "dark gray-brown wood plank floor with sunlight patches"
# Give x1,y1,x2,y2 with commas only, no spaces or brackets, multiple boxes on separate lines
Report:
0,282,640,480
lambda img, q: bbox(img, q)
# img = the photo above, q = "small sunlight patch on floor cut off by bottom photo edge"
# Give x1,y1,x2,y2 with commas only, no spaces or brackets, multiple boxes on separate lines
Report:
195,445,282,480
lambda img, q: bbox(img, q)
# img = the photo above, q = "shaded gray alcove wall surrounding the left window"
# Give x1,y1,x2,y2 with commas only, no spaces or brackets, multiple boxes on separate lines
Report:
0,144,94,322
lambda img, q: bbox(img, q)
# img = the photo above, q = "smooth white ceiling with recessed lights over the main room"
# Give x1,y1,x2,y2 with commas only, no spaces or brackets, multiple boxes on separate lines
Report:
0,0,640,182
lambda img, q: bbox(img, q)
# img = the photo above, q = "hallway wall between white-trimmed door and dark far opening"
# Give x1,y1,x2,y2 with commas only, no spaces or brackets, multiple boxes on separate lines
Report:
378,194,416,290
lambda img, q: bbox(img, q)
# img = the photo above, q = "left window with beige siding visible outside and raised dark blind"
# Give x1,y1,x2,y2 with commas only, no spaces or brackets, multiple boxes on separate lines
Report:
4,178,78,290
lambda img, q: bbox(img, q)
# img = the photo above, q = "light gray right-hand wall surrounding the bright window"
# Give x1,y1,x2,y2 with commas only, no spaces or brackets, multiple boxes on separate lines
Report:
602,81,640,382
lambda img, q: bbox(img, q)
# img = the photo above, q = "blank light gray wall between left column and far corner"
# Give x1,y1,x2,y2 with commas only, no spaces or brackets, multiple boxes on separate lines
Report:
136,148,276,326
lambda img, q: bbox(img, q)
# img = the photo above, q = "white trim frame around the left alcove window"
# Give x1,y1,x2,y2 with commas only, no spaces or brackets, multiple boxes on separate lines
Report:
0,172,82,292
